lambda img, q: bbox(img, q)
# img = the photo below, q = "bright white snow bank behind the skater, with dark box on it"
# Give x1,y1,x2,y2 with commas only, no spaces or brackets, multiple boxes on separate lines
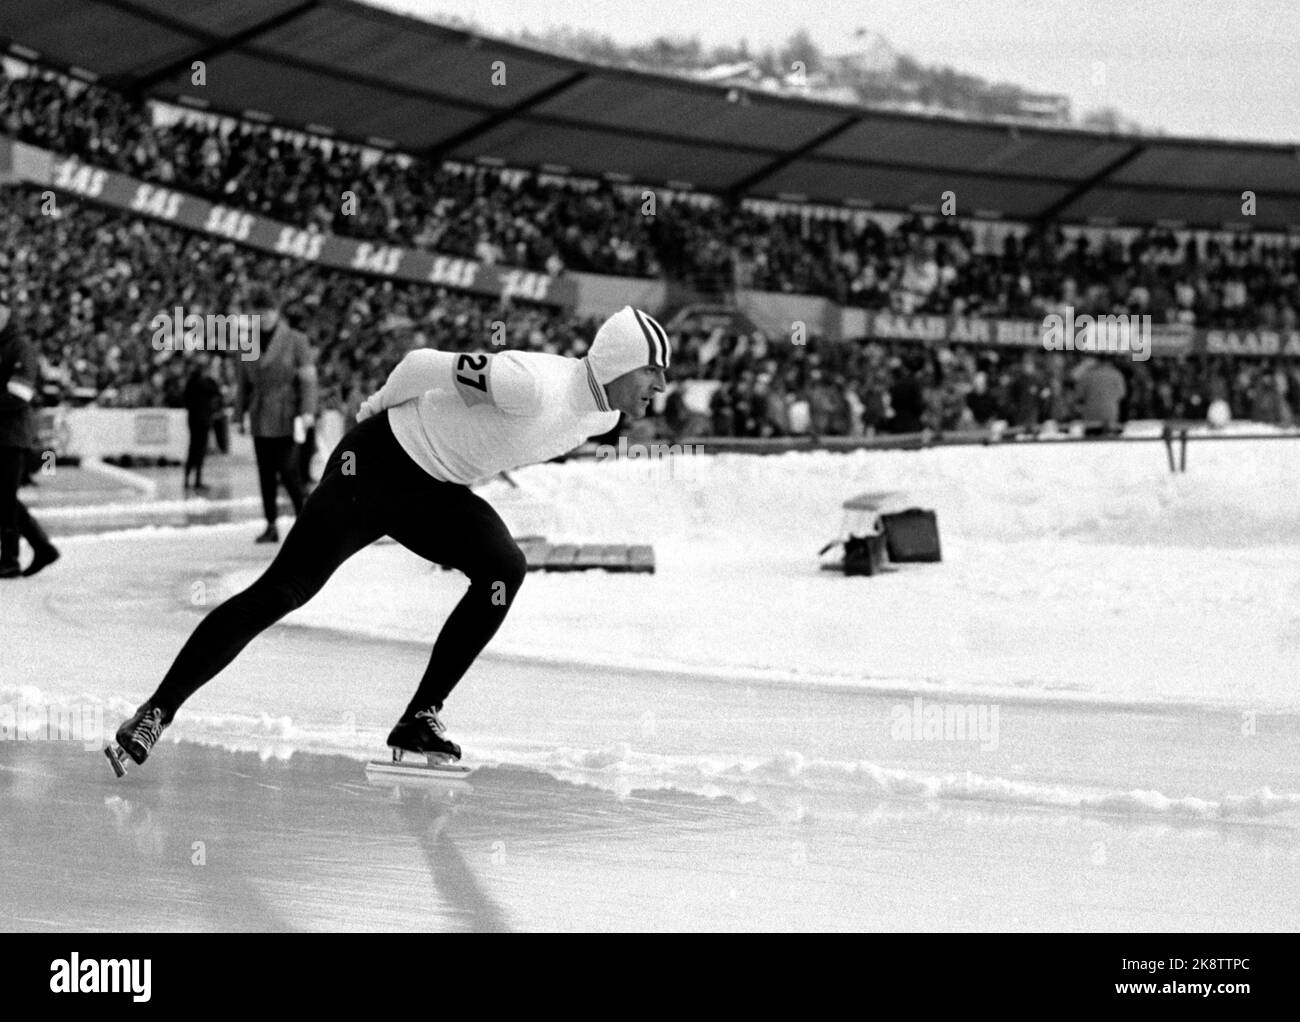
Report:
189,439,1300,709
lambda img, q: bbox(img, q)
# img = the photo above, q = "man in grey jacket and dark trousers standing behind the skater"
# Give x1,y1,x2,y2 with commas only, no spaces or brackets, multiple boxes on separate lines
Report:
238,295,316,544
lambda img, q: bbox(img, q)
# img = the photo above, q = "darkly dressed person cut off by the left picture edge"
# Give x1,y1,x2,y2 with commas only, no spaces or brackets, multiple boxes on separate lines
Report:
0,290,59,579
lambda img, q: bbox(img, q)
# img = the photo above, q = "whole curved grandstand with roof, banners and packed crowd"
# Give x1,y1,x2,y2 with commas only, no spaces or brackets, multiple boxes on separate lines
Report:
0,0,1300,438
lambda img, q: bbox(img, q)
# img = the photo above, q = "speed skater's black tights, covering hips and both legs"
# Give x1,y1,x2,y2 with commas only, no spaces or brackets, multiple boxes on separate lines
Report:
153,413,528,719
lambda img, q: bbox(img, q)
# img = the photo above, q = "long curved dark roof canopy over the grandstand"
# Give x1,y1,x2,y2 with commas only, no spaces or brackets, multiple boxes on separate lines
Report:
0,0,1300,229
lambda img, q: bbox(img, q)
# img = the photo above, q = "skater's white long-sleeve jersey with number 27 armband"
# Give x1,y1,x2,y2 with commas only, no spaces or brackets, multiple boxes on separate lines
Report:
356,348,619,486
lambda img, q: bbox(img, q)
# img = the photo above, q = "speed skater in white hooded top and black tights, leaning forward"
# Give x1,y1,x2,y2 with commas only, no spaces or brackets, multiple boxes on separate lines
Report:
107,306,671,766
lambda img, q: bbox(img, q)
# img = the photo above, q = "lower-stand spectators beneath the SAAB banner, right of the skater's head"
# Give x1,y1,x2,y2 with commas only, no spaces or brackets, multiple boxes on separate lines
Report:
681,339,1300,437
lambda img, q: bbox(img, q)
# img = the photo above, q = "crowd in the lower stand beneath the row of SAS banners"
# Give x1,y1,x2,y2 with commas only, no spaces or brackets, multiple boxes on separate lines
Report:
0,190,593,407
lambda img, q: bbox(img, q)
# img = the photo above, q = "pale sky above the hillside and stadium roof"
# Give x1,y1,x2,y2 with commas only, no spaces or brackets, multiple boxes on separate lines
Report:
368,0,1300,142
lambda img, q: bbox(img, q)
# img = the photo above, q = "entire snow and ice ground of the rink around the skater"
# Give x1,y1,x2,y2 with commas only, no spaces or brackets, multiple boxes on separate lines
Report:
0,442,1300,931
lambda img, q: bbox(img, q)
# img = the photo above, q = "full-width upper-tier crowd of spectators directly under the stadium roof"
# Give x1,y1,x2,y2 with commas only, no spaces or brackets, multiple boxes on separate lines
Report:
0,57,1300,329
